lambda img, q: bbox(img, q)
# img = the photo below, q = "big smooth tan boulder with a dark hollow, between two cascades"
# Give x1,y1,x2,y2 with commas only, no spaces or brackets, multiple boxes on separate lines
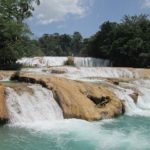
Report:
12,73,124,120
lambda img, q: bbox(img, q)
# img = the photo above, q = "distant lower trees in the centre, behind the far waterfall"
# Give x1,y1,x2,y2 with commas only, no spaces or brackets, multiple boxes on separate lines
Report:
39,32,83,56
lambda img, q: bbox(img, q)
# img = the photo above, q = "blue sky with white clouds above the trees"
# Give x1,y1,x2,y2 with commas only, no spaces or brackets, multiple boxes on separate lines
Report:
27,0,150,37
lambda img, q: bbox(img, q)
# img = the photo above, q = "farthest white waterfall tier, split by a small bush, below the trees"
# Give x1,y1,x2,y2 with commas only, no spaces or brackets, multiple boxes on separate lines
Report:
17,57,110,67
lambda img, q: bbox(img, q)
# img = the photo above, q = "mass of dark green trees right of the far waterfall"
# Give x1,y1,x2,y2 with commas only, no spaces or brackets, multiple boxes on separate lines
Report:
88,15,150,67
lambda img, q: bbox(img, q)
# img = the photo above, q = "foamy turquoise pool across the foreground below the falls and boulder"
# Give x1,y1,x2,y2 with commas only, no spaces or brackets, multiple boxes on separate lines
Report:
0,116,150,150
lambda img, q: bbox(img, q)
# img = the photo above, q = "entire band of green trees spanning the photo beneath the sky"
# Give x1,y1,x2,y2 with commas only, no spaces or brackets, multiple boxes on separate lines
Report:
0,0,150,69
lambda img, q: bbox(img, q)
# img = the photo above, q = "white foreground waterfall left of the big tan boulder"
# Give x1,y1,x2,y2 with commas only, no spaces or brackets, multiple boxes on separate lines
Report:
6,85,63,124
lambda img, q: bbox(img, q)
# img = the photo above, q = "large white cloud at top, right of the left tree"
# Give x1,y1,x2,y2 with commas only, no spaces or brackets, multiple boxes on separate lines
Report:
33,0,93,24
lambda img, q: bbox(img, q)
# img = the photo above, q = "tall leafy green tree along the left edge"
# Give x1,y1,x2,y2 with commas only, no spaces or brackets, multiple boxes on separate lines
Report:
0,0,39,69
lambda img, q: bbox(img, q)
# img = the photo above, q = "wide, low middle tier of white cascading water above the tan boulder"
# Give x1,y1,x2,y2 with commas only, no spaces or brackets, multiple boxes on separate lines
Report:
22,66,140,80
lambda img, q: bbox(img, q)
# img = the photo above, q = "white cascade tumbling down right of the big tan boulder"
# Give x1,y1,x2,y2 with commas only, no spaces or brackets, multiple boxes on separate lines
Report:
110,81,150,117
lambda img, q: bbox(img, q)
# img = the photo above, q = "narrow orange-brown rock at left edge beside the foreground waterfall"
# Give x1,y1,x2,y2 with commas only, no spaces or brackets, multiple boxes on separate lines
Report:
0,84,9,124
